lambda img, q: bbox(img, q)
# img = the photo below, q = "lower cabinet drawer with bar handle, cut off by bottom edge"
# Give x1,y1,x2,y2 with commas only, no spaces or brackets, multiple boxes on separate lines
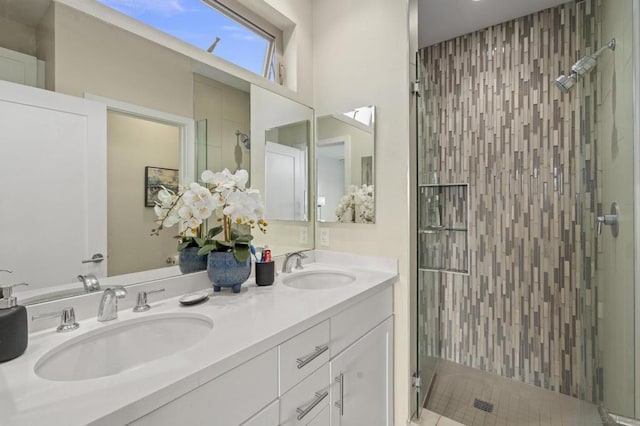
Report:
280,364,329,426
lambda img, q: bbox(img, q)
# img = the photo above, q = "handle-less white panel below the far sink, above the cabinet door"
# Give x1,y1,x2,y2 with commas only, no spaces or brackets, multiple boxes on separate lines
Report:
331,287,393,358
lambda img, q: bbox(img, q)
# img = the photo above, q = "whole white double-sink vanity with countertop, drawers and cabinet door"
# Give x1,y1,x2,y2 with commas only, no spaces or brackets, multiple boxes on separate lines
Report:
0,251,398,426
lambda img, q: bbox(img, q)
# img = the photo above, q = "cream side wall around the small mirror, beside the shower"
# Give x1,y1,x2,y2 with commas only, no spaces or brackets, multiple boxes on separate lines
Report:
313,0,414,425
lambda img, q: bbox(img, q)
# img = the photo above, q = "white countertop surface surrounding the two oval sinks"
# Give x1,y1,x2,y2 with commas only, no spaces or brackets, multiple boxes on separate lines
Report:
0,251,398,426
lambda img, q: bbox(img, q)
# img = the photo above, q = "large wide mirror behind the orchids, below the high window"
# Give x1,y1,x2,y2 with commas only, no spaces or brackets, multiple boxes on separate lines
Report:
0,0,314,303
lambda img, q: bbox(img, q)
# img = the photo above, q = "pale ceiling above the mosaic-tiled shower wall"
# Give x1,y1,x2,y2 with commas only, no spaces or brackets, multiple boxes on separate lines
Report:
418,0,567,47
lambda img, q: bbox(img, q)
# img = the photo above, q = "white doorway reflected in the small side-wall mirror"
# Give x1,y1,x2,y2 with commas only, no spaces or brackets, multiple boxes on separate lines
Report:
316,135,351,222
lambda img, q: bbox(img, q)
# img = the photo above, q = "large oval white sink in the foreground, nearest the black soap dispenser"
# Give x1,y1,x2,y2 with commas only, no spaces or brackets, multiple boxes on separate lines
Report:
34,314,213,381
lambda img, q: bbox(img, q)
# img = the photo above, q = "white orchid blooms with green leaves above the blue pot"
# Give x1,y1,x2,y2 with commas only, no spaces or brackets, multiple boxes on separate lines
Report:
151,169,267,262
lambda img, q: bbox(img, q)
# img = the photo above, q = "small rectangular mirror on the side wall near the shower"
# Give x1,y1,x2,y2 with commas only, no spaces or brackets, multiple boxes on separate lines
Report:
316,106,375,223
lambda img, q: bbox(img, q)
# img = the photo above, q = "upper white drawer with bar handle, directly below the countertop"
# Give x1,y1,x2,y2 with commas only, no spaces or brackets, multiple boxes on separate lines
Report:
278,320,331,395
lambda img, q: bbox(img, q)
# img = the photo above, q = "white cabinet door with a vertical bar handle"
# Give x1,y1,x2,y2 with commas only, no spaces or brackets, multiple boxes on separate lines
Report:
330,317,393,426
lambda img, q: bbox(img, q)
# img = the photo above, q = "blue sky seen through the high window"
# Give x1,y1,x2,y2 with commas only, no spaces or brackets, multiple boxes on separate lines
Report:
98,0,269,75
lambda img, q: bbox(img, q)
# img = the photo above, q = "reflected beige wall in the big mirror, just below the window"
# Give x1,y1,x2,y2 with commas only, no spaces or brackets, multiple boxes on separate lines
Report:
52,3,193,117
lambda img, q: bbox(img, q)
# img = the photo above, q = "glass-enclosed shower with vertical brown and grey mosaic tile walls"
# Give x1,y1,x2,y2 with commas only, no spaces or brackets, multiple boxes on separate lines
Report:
414,0,640,424
